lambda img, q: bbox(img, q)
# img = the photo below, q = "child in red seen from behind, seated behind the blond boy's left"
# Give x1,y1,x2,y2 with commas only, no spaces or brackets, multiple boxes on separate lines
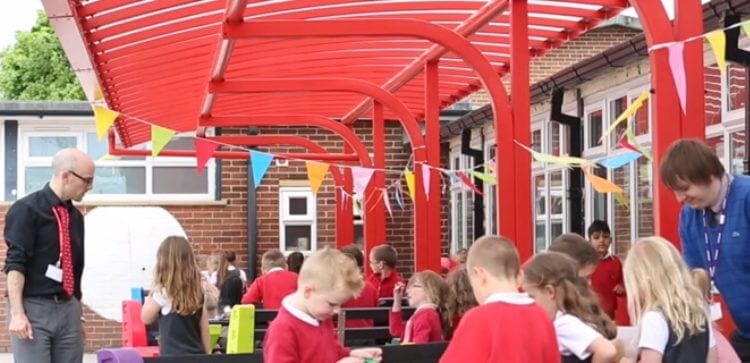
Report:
242,249,297,309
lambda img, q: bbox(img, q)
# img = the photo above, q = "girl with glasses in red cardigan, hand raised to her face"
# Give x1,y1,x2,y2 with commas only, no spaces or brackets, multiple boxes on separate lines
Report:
388,271,452,344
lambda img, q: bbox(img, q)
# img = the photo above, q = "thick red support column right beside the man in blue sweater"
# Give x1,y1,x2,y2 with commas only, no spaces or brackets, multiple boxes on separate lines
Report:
630,0,705,247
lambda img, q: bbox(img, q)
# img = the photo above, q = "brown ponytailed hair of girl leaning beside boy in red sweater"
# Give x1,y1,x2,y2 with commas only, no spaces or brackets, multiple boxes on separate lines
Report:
524,252,617,339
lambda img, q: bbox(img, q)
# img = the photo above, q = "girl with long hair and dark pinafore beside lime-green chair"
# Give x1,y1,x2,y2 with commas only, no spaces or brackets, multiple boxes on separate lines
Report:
141,236,211,356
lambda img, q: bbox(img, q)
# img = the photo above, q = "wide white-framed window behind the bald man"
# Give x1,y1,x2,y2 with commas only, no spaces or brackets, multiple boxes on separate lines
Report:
18,124,215,201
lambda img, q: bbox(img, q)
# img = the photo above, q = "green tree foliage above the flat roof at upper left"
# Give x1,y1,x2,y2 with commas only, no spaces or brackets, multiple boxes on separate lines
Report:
0,11,85,100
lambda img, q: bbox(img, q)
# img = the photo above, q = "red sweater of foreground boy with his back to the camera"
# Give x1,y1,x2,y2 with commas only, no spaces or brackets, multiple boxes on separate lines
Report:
440,293,560,363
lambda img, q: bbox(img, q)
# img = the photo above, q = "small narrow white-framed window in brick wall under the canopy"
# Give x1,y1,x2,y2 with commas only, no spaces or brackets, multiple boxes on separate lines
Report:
279,187,317,252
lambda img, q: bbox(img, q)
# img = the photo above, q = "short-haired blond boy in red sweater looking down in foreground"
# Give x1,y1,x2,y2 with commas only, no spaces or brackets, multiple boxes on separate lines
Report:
263,248,381,363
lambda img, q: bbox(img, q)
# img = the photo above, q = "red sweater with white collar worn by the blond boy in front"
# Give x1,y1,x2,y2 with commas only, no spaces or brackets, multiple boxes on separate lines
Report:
263,296,349,363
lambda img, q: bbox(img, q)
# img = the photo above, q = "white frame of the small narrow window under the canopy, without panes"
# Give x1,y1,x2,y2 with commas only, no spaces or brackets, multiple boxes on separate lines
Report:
279,187,318,255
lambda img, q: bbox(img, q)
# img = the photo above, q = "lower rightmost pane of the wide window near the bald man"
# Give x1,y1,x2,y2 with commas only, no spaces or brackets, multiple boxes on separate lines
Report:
152,166,208,194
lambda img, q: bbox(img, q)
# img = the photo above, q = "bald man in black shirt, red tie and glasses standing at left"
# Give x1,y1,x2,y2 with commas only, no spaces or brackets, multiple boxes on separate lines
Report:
4,149,94,363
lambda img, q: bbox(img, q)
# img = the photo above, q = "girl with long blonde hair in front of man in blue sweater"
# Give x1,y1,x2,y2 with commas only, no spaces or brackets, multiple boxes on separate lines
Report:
623,236,716,363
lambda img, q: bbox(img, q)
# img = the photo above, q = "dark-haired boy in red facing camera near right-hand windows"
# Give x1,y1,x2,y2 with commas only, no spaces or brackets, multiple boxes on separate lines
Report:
587,220,625,319
